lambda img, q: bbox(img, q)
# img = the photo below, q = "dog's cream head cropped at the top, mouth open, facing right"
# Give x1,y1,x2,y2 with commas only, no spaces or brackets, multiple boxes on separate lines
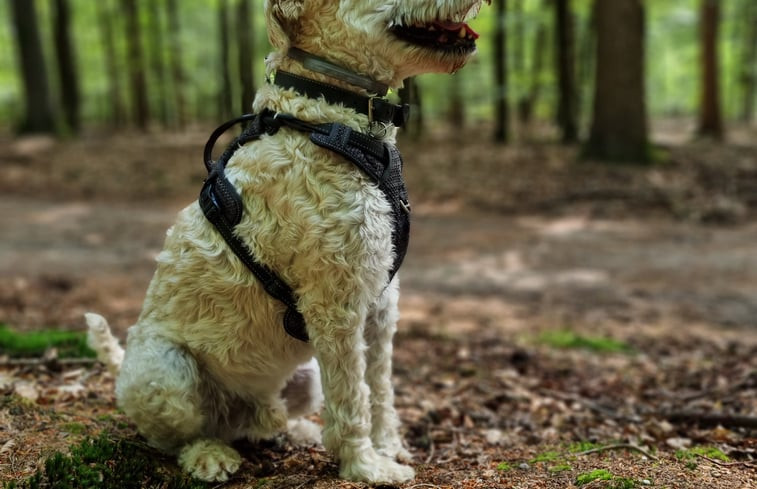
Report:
266,0,489,87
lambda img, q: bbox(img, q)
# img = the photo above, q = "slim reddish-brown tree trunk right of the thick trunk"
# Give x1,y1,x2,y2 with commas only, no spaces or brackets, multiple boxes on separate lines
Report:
697,0,723,140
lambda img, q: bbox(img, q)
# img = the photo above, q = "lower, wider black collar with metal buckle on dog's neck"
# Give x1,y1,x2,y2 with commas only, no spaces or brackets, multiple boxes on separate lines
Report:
273,70,410,127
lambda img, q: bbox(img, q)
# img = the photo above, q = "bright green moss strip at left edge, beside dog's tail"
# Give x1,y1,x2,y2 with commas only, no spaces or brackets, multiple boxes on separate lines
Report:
0,324,96,358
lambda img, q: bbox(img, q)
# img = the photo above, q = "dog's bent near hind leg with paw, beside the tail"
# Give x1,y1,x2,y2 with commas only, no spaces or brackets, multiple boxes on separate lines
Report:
116,326,241,481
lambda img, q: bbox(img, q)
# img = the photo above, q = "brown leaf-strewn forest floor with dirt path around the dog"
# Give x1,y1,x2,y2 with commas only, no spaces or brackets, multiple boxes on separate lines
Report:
0,119,757,489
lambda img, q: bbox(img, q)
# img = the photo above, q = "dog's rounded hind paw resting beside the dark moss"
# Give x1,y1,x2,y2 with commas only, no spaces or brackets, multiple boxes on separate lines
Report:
179,439,242,482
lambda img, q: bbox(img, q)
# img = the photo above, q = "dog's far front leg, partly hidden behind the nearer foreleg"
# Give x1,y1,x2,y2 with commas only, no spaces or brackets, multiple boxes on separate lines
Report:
365,278,412,462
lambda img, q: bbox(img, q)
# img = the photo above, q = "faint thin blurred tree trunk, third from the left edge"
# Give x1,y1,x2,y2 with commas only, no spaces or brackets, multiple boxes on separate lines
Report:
95,0,127,127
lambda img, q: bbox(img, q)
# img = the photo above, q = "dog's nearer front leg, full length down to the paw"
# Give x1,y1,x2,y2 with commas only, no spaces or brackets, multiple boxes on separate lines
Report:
309,307,415,482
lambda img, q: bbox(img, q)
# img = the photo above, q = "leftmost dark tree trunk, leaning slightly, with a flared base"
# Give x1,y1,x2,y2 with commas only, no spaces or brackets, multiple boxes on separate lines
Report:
11,0,55,133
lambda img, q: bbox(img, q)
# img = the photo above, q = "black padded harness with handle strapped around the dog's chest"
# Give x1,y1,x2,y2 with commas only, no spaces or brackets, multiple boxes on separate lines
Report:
199,111,410,342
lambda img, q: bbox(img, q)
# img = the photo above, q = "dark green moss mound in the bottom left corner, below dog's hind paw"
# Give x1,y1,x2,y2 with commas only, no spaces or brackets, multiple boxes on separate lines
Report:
4,433,209,489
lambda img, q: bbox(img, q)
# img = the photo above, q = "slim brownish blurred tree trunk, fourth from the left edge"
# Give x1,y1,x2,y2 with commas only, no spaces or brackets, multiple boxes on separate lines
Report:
121,0,150,130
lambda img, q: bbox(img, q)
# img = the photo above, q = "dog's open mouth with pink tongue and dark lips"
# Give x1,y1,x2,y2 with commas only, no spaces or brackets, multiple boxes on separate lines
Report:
392,21,478,52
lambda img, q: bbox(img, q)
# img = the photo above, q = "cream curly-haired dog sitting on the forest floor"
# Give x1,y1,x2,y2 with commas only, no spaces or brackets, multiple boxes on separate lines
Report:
87,0,482,482
